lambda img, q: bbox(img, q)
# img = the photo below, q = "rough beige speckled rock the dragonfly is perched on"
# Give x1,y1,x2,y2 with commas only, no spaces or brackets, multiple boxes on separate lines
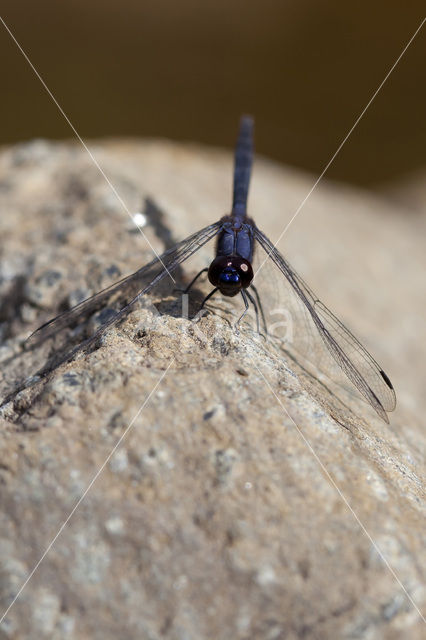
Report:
0,141,426,640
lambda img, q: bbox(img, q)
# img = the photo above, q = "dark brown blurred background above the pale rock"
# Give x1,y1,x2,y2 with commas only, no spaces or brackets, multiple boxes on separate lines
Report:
0,0,426,186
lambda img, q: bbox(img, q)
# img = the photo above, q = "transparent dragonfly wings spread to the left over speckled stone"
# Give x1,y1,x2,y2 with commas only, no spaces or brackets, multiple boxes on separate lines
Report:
28,221,221,375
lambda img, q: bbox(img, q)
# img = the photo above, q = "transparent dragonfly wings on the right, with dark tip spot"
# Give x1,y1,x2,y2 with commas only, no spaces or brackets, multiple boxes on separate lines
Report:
254,228,396,422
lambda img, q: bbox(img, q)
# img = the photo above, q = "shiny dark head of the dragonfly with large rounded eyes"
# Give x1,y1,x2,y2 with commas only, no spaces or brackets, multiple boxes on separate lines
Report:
209,256,253,296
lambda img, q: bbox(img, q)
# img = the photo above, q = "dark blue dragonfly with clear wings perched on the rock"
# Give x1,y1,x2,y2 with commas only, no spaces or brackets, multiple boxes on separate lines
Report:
28,116,396,422
